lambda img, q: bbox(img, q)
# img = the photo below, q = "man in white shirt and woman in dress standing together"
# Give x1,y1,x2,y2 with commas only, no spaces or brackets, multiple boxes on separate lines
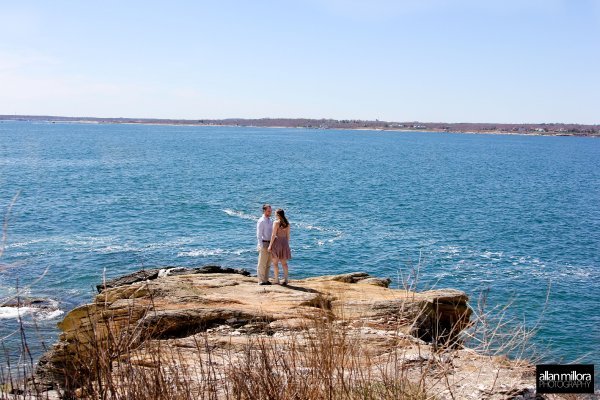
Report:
256,204,292,286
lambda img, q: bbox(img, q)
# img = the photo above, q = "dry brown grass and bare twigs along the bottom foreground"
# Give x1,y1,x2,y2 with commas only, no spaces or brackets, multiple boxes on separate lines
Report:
0,262,552,400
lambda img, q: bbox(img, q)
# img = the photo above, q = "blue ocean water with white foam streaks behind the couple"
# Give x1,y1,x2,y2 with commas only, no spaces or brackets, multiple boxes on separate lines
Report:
0,122,600,363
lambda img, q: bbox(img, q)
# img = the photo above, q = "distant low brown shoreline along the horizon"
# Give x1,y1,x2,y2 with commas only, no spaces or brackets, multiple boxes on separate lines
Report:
0,115,600,137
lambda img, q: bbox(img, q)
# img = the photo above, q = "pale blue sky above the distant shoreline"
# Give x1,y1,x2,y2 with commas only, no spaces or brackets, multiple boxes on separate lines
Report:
0,0,600,123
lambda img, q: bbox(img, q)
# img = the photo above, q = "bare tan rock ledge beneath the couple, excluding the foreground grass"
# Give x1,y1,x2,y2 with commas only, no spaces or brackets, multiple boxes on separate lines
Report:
38,266,533,399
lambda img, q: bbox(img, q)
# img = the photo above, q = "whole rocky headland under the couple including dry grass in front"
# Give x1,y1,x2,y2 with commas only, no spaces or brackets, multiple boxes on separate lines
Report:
0,266,544,400
